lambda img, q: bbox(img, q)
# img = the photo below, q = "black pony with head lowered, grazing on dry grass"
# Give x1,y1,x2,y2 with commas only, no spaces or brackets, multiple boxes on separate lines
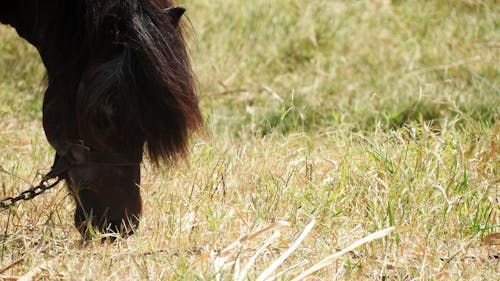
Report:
0,0,202,237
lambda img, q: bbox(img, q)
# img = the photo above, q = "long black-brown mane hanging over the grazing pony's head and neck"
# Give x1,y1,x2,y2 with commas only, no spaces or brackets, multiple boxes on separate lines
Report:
76,0,201,160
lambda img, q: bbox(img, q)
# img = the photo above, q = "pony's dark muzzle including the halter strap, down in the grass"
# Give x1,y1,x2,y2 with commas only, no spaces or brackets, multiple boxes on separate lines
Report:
47,144,142,239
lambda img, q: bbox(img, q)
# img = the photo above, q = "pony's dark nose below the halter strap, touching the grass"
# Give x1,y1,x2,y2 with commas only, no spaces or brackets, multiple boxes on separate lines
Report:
68,165,142,239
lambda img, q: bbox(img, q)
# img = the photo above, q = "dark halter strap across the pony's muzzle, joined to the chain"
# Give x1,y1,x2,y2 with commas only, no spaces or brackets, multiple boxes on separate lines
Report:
44,143,142,179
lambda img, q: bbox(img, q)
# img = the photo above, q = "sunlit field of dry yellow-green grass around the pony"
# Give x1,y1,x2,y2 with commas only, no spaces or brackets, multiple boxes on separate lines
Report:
0,0,500,280
